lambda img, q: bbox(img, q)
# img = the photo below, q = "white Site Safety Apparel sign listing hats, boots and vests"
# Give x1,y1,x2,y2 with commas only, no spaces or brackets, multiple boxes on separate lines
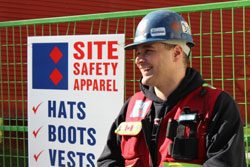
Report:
28,34,124,167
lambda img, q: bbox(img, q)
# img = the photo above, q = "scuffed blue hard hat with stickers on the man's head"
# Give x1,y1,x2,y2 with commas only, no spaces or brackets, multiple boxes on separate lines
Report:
125,10,194,50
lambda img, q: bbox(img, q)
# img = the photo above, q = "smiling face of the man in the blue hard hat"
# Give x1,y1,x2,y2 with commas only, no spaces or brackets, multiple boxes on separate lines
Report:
135,42,175,87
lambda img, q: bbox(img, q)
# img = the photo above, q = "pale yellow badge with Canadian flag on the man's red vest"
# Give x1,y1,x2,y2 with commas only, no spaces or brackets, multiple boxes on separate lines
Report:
115,122,142,136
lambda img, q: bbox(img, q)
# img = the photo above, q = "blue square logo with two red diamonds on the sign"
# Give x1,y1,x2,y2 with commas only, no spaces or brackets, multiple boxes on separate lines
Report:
32,43,68,90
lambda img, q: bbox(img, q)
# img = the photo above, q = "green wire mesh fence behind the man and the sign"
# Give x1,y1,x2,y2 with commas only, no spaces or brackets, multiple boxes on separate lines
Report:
0,0,250,167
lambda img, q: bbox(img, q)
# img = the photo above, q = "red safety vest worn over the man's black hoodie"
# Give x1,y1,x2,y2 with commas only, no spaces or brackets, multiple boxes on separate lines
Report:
116,85,221,167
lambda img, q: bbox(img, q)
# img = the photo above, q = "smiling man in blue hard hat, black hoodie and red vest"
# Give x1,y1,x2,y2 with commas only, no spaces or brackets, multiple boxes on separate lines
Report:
98,11,245,167
